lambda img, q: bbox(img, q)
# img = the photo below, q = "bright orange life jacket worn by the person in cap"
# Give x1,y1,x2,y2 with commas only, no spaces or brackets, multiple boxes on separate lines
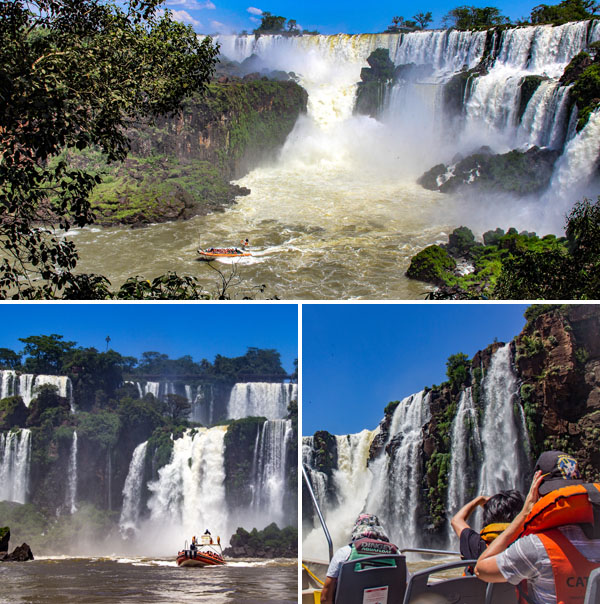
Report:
517,483,600,604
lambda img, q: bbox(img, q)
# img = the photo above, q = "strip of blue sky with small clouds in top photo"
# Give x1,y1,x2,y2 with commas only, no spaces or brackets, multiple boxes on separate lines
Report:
166,0,558,34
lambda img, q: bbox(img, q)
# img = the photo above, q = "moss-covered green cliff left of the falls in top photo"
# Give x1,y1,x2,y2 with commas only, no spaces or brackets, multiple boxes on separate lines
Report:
91,80,308,226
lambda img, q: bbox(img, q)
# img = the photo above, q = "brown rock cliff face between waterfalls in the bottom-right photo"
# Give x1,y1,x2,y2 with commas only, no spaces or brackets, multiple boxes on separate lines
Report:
303,304,600,546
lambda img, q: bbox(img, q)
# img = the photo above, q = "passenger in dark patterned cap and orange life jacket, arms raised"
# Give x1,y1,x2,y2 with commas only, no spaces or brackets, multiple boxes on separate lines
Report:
475,451,600,604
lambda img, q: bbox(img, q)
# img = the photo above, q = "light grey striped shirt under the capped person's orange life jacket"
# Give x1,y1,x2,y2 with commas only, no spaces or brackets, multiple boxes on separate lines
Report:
496,524,600,604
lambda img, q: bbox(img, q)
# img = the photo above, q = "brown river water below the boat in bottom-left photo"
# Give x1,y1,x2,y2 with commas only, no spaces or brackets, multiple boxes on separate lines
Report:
0,557,298,604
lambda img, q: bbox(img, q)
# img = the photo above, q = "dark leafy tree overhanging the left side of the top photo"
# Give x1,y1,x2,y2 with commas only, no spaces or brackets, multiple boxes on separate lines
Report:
0,0,217,299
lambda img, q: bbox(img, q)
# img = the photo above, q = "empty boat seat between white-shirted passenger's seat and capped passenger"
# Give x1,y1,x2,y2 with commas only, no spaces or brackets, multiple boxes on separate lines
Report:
404,560,488,604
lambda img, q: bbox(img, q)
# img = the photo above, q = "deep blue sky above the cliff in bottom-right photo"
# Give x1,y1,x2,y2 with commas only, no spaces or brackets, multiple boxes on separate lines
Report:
302,303,527,436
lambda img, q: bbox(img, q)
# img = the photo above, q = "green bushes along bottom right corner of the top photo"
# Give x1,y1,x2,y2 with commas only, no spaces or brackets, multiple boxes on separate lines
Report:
406,198,600,300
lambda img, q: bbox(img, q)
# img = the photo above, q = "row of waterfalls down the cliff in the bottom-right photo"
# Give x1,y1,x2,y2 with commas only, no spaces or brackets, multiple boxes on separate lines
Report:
302,344,530,557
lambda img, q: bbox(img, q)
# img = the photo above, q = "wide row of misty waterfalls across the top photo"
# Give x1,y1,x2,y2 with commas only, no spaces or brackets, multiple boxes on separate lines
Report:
217,20,600,232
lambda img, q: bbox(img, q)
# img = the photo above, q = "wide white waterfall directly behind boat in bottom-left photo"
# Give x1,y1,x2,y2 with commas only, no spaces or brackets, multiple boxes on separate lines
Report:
148,426,229,551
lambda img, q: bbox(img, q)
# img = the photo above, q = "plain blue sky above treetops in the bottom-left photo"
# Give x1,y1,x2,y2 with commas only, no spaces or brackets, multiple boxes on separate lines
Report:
0,302,298,372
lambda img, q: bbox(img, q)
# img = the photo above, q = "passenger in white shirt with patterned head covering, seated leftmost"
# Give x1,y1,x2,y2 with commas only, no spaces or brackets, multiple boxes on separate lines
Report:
321,514,398,604
